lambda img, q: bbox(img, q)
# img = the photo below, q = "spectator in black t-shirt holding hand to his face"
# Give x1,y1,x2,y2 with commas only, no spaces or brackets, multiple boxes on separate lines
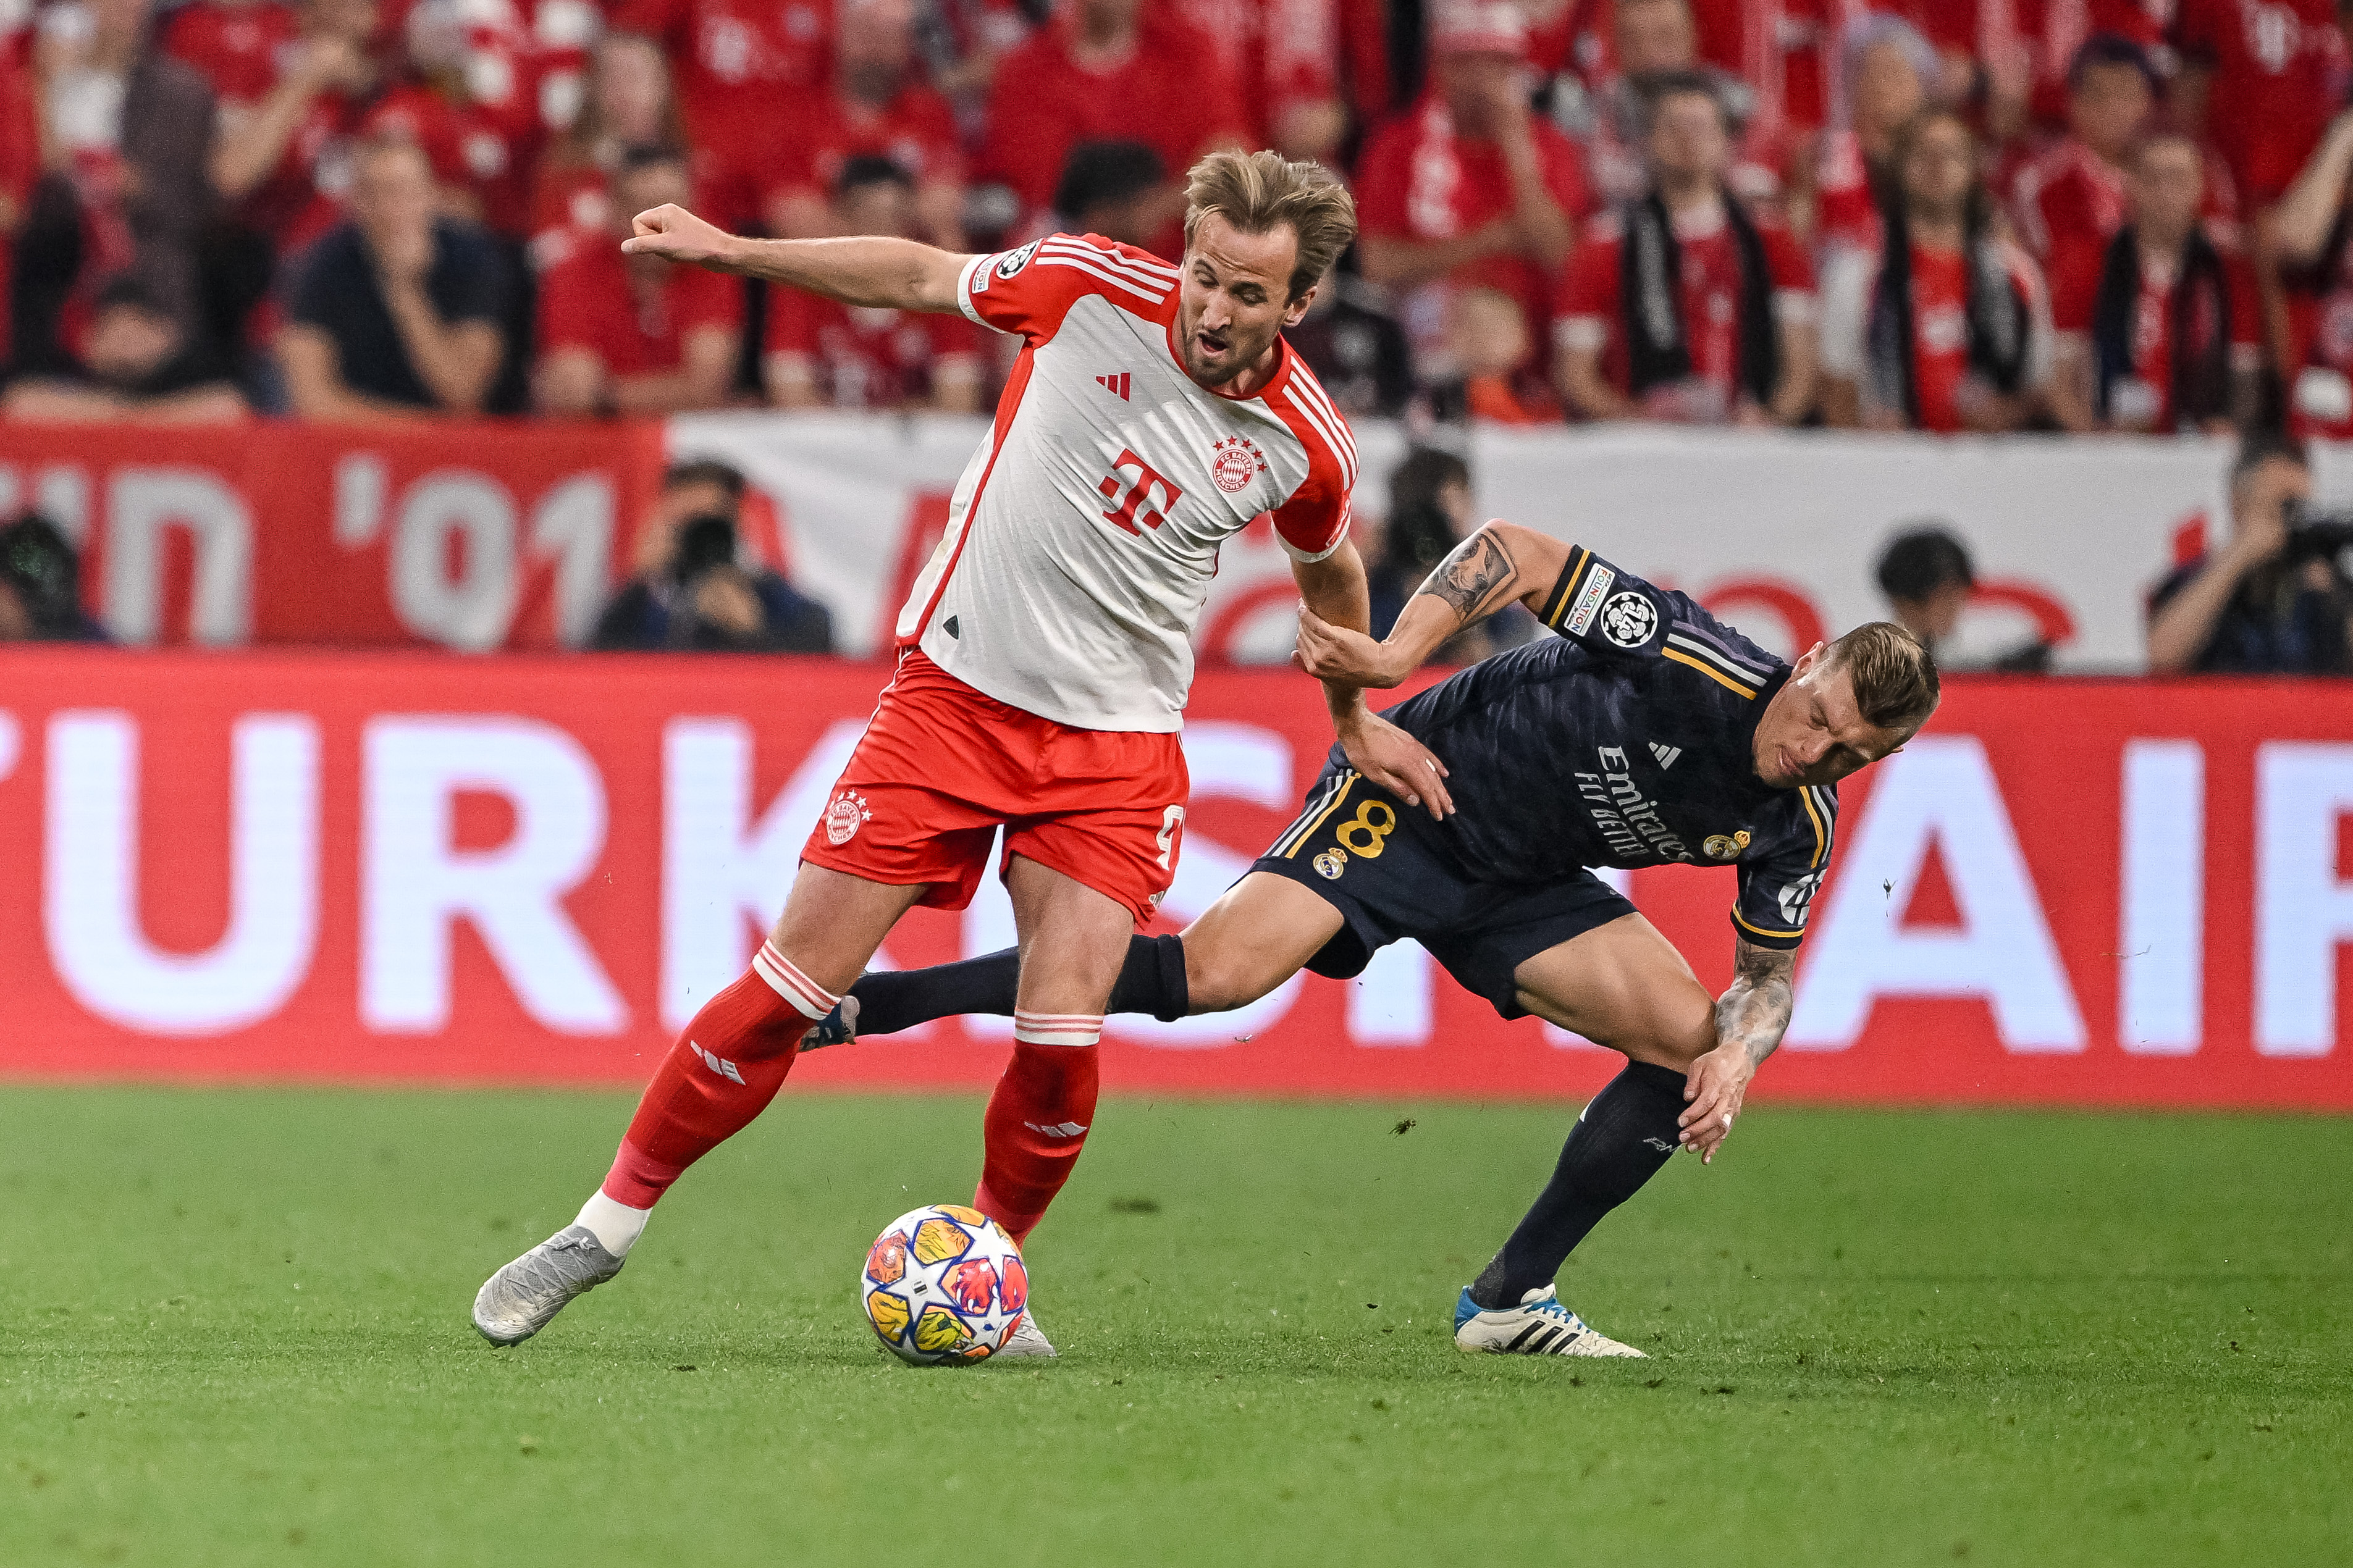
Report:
277,141,508,423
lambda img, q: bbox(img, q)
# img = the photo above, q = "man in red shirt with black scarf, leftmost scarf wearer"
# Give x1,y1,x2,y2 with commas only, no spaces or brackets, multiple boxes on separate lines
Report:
1555,73,1817,426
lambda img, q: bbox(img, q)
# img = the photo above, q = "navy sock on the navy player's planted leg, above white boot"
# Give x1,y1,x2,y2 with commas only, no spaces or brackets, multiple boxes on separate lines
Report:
1471,1063,1685,1312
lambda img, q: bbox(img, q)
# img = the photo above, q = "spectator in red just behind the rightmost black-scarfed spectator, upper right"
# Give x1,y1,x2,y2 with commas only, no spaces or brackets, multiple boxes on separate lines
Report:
2010,33,2155,270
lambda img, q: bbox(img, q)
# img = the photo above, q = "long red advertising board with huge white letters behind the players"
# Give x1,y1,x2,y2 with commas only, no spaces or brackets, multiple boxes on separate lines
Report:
0,649,2353,1110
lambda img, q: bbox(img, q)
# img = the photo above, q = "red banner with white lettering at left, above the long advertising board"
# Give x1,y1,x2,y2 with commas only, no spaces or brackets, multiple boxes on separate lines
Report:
0,423,663,651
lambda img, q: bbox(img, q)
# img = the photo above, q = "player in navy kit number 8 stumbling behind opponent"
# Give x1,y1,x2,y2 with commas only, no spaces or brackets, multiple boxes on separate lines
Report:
805,522,1937,1356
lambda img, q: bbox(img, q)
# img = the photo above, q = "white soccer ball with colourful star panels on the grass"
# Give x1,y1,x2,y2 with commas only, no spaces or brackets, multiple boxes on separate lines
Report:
859,1204,1029,1366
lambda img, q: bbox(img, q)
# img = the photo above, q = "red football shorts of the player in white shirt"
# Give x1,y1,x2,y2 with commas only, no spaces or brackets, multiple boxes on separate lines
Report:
800,649,1190,926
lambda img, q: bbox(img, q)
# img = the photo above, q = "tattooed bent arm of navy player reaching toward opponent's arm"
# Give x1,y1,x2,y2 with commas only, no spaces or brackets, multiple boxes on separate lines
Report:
1297,522,1572,687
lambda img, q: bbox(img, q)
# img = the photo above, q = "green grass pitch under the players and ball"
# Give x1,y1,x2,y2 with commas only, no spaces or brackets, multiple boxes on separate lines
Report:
0,1088,2353,1568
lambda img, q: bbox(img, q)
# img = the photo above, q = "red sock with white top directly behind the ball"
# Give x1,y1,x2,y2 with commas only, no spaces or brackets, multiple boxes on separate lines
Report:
972,1013,1103,1241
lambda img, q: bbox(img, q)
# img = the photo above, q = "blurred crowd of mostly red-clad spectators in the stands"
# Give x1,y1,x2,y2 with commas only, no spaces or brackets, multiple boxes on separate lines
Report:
0,0,2353,435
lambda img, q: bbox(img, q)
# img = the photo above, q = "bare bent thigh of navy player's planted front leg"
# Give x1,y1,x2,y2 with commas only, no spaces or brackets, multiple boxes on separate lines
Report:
1510,915,1715,1070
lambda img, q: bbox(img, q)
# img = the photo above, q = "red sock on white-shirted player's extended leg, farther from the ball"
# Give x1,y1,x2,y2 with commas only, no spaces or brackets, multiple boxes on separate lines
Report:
605,942,838,1209
